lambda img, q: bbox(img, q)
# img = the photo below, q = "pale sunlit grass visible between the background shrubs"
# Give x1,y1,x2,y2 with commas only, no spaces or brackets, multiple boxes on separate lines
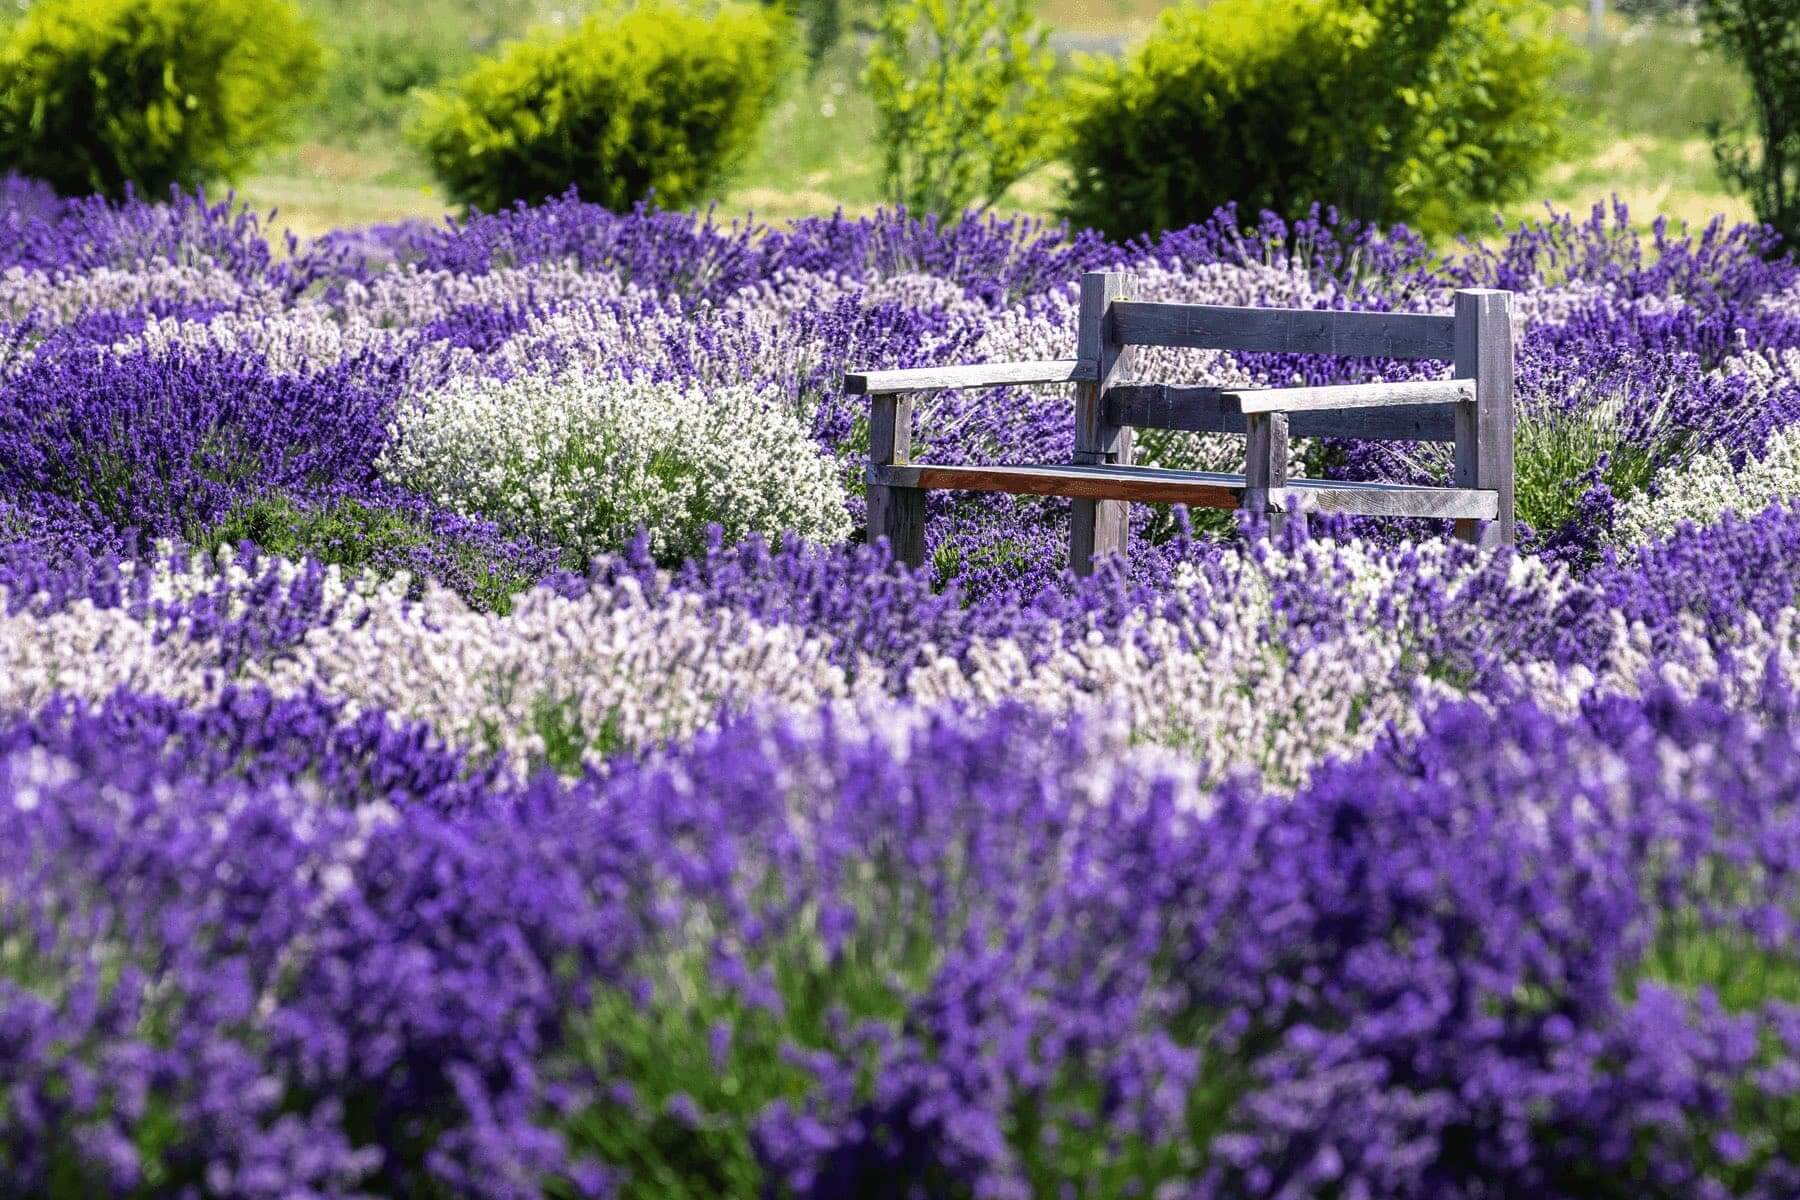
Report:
225,0,1751,246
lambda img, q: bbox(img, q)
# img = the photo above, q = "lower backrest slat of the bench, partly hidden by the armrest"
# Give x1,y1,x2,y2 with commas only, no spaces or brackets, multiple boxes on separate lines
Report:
1107,383,1456,443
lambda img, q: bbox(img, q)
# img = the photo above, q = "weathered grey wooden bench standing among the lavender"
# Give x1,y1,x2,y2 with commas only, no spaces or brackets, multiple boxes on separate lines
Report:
844,272,1514,574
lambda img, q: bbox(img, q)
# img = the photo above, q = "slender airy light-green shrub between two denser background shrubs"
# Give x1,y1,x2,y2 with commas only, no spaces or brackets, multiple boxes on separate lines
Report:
862,0,1058,219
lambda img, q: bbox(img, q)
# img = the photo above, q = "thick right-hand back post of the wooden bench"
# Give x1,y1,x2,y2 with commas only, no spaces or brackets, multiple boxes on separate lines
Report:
1456,288,1514,547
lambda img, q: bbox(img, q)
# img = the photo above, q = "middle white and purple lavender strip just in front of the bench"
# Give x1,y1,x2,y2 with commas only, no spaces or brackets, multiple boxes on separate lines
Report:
10,506,1800,788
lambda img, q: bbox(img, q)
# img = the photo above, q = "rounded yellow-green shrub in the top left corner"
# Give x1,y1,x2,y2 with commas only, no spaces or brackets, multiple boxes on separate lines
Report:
0,0,322,196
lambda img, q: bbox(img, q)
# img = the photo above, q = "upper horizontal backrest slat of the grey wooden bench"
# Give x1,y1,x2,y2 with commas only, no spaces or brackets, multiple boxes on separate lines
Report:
1108,300,1456,360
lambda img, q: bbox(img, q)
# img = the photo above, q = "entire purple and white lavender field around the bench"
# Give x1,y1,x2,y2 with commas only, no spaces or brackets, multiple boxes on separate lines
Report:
10,182,1800,1200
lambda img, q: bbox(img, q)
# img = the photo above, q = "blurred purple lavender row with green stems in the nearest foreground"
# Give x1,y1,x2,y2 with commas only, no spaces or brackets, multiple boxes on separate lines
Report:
10,682,1800,1198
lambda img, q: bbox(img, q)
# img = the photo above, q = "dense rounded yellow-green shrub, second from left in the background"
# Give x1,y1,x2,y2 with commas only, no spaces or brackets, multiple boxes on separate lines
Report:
414,2,788,212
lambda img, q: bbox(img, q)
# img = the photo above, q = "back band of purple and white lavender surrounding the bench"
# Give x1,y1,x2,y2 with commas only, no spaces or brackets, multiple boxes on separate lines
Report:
10,188,1800,590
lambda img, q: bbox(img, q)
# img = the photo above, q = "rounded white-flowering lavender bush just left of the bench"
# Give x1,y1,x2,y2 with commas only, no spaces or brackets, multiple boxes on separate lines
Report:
380,372,850,558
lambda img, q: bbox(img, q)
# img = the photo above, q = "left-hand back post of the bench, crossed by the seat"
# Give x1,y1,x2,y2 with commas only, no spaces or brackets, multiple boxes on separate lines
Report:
1069,272,1134,576
